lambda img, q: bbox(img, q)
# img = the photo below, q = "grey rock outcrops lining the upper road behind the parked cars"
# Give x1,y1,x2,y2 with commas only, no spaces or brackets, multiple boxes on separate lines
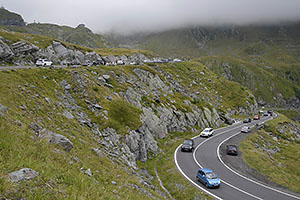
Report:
0,36,147,65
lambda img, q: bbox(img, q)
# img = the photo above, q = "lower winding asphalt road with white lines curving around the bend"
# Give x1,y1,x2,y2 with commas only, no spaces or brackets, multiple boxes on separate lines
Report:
174,117,300,200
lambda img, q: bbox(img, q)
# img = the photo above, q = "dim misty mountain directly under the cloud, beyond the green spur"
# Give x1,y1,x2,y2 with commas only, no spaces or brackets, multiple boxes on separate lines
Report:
106,23,300,57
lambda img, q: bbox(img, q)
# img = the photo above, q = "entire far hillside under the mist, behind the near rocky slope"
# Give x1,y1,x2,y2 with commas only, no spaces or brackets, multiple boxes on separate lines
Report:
106,23,300,110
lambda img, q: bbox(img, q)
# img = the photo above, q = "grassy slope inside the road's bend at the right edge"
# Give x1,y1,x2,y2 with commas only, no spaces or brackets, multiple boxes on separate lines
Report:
240,115,300,192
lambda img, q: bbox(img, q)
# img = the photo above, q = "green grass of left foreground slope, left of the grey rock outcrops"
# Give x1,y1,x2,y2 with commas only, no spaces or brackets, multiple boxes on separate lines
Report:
0,69,157,199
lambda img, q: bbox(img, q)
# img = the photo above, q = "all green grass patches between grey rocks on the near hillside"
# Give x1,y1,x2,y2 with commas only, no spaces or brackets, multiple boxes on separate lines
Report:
0,62,255,199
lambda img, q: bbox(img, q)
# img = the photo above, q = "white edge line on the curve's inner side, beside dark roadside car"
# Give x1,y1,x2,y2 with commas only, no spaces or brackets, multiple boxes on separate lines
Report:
217,128,300,199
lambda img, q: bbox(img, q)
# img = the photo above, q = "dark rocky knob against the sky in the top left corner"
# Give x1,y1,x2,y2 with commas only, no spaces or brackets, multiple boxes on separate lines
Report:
0,7,25,27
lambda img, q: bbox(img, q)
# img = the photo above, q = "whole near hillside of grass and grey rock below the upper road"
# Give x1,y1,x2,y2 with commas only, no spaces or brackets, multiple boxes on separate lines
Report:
0,55,257,199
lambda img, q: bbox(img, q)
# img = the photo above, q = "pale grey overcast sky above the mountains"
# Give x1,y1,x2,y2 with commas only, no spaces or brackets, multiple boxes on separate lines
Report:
0,0,300,34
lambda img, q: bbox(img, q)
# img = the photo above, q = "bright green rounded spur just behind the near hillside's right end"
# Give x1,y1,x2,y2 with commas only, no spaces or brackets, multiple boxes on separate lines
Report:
197,56,298,103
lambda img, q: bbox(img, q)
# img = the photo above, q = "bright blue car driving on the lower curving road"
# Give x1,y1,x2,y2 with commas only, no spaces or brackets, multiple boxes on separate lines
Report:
196,168,221,188
